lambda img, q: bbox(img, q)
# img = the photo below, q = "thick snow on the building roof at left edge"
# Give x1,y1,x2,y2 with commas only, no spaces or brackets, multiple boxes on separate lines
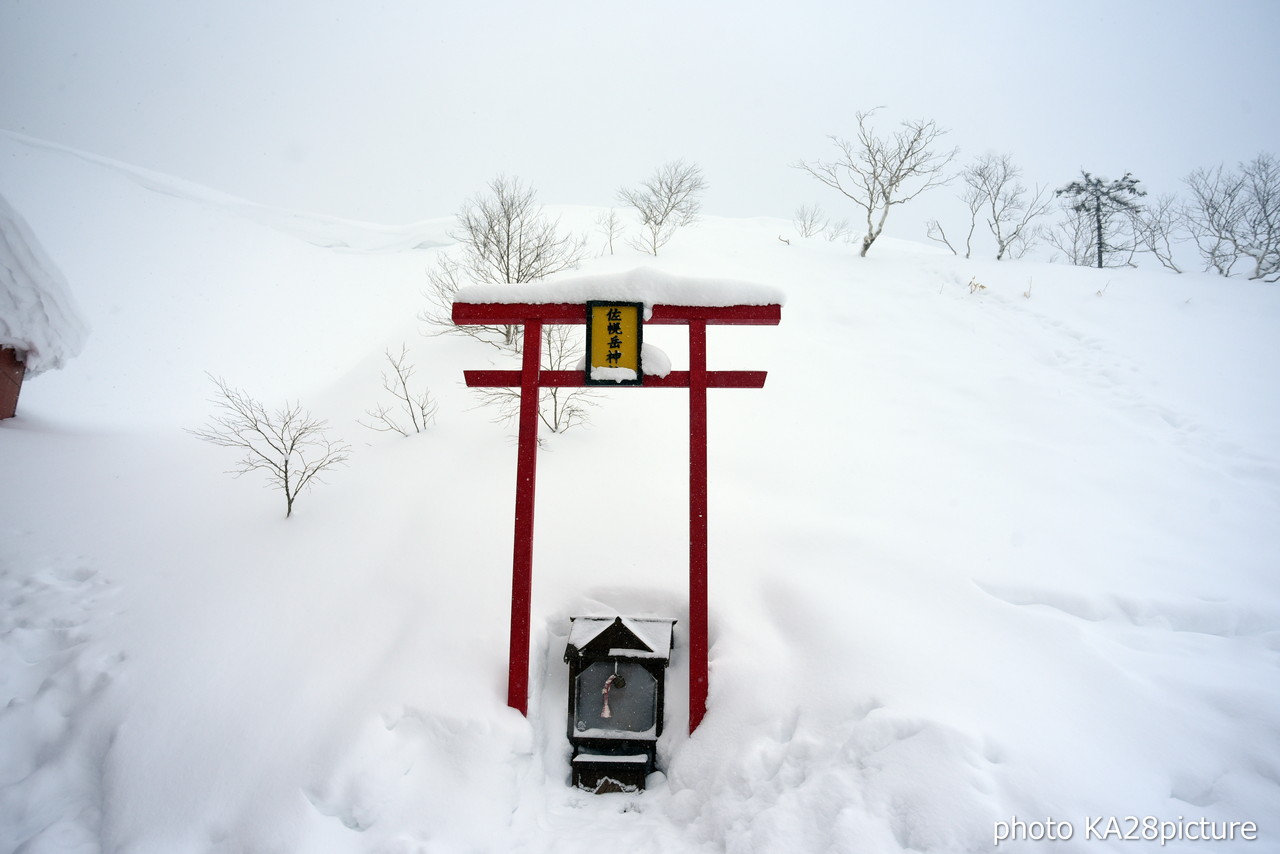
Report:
0,196,87,378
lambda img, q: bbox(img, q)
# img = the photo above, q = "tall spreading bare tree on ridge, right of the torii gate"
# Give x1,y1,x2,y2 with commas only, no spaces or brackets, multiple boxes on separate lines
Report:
795,108,956,257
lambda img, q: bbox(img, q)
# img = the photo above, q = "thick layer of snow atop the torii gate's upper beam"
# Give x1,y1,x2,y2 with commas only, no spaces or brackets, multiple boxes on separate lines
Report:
454,266,786,309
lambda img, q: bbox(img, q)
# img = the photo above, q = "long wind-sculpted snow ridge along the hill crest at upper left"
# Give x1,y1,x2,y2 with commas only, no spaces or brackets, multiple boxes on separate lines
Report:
0,131,453,255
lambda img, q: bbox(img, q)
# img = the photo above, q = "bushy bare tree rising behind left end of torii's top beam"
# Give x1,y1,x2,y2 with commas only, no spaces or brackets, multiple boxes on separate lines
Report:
420,175,586,347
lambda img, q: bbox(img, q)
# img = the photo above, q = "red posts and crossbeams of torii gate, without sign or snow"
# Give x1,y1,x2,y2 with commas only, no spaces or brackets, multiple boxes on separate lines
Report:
453,294,782,732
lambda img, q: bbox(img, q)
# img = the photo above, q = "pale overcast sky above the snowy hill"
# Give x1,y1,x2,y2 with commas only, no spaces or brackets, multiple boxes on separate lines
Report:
0,0,1280,236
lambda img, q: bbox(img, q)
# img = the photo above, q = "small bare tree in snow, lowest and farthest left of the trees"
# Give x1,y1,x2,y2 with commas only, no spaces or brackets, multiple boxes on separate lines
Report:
187,376,351,519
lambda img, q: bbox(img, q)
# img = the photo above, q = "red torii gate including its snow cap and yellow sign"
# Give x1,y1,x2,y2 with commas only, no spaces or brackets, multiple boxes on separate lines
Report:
453,270,783,732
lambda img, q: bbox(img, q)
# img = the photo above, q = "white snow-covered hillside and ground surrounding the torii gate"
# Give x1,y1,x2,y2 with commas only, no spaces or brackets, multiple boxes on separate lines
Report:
0,128,1280,854
